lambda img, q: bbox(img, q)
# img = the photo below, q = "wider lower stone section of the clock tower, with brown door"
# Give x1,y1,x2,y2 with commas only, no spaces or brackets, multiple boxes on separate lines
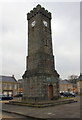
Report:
23,71,59,102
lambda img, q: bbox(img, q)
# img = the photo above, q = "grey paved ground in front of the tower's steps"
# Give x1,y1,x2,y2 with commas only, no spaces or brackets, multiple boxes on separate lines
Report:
2,97,81,119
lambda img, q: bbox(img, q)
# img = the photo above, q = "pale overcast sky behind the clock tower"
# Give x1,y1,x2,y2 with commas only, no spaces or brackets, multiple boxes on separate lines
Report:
0,0,80,79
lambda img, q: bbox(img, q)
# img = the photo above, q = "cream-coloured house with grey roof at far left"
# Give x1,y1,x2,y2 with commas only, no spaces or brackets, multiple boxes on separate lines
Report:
0,75,18,96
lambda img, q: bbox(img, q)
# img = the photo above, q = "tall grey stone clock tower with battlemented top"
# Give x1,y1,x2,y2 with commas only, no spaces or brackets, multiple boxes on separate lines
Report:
23,5,59,101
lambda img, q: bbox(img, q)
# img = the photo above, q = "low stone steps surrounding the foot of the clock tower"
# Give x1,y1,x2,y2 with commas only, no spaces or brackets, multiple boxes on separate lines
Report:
6,99,77,108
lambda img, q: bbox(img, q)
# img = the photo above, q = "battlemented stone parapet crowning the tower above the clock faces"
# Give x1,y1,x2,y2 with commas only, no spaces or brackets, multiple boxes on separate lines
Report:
27,4,51,20
